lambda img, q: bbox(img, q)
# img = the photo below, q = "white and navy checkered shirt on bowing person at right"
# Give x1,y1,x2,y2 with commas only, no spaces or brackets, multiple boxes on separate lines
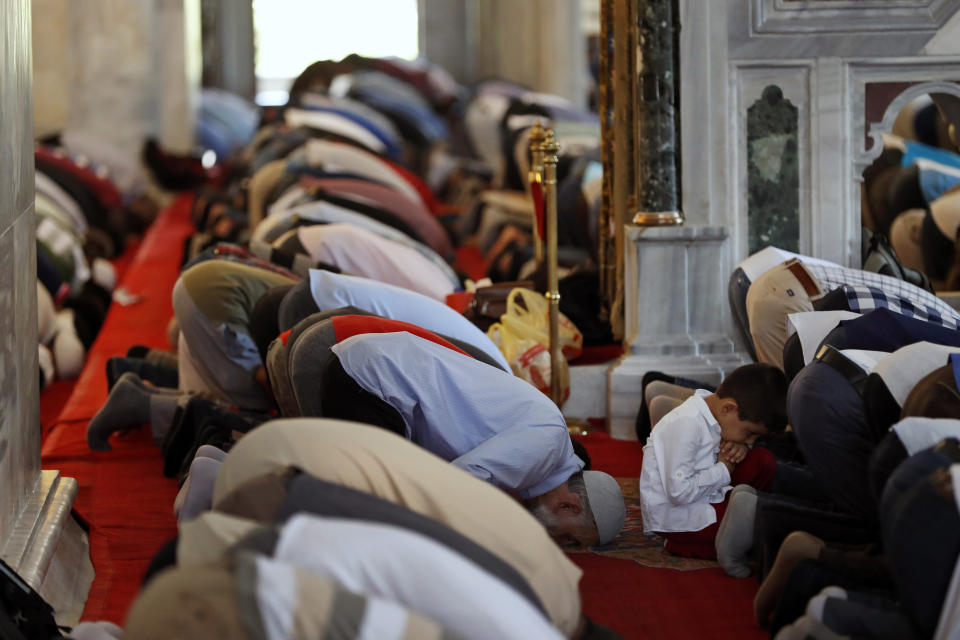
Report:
804,265,960,329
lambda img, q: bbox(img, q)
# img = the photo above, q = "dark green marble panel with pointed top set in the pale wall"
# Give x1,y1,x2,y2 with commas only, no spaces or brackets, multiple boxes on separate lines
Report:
747,85,800,253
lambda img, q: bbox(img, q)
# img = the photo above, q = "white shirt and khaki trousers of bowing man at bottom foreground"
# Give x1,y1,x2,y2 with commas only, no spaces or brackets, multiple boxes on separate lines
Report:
177,512,563,640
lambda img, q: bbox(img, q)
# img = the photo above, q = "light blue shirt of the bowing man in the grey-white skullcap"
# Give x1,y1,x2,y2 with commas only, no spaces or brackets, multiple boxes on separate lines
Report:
333,332,583,498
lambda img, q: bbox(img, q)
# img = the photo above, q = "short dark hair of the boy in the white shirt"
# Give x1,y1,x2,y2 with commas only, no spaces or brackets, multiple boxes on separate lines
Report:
717,363,787,433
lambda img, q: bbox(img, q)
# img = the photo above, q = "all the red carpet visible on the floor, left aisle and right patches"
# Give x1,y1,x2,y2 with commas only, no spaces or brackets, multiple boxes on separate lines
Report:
43,198,765,639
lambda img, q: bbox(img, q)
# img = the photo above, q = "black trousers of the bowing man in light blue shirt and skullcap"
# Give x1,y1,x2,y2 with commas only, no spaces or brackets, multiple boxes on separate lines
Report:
320,358,407,437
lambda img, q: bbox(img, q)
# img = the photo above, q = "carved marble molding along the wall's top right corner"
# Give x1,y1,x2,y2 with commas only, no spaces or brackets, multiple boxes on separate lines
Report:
750,0,956,34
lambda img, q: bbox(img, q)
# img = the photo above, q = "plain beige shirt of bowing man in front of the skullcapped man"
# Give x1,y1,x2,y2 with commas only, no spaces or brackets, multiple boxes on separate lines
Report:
212,418,585,637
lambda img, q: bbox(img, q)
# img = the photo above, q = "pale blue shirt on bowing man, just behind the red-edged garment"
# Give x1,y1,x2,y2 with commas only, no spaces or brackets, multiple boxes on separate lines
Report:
310,269,510,371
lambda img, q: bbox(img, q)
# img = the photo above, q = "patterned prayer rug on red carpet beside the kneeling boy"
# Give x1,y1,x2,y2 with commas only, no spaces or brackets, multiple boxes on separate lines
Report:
568,478,720,571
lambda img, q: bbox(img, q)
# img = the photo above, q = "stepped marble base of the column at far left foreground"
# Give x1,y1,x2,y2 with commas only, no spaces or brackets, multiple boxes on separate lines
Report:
0,470,94,627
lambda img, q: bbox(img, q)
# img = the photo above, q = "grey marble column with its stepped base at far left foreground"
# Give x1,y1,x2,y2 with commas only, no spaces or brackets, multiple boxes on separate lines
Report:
0,0,93,624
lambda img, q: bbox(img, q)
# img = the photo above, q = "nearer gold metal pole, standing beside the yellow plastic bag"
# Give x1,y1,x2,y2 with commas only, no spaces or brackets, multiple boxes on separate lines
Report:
540,129,563,407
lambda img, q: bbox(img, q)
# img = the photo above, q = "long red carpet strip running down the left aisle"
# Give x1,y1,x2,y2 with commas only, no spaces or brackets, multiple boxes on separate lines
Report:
42,197,192,623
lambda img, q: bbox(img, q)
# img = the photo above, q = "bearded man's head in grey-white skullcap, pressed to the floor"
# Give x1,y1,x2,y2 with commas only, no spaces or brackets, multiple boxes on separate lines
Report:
526,471,626,547
